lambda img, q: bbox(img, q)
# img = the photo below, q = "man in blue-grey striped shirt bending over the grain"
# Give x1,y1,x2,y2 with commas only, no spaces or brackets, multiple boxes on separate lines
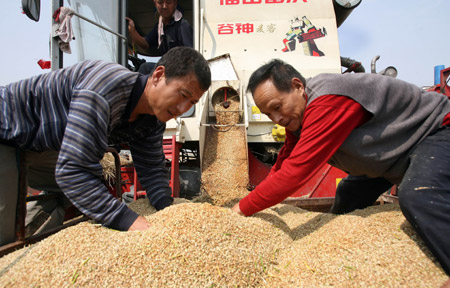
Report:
0,47,211,245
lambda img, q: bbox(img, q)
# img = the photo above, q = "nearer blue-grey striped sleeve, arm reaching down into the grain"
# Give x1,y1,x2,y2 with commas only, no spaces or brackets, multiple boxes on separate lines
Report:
56,90,138,231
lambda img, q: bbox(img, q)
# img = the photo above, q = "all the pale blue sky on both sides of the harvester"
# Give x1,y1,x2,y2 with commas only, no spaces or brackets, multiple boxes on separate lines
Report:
0,0,450,87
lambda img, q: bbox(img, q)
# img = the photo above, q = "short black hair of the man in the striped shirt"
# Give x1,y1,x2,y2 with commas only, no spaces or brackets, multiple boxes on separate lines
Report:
156,46,211,90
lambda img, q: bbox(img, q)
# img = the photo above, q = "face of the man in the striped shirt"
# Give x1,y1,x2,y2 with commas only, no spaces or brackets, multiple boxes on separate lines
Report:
148,66,205,122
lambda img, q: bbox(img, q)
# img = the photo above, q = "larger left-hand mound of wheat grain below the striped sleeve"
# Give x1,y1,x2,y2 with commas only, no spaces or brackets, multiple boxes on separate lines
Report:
0,199,291,287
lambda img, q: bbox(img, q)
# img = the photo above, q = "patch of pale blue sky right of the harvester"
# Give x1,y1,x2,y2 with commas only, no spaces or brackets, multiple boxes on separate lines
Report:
338,0,450,86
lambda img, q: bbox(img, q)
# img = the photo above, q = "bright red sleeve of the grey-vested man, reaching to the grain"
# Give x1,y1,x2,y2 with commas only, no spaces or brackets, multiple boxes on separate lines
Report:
239,95,372,216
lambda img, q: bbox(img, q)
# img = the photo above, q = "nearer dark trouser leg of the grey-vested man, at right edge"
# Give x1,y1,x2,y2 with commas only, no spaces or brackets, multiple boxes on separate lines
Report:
398,127,450,275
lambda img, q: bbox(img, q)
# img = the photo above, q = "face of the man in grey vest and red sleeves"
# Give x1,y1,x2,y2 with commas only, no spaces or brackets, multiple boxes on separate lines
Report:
253,78,306,131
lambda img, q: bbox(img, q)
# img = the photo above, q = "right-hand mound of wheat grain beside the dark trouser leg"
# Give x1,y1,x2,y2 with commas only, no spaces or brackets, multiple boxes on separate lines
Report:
257,204,448,288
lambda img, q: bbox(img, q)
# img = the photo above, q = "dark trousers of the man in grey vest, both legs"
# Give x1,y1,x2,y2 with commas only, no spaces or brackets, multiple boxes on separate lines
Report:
330,127,450,275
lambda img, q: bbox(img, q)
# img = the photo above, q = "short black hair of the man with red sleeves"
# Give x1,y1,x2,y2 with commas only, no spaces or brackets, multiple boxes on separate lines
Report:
247,59,306,94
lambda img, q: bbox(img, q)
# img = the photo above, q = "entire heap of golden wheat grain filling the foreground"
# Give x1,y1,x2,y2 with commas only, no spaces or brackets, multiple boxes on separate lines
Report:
0,199,447,287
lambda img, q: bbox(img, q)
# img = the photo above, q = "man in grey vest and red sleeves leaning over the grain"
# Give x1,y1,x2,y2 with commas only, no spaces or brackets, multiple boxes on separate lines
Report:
232,60,450,282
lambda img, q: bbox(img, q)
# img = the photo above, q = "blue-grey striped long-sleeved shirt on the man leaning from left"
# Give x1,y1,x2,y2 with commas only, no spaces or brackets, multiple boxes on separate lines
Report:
0,60,172,230
